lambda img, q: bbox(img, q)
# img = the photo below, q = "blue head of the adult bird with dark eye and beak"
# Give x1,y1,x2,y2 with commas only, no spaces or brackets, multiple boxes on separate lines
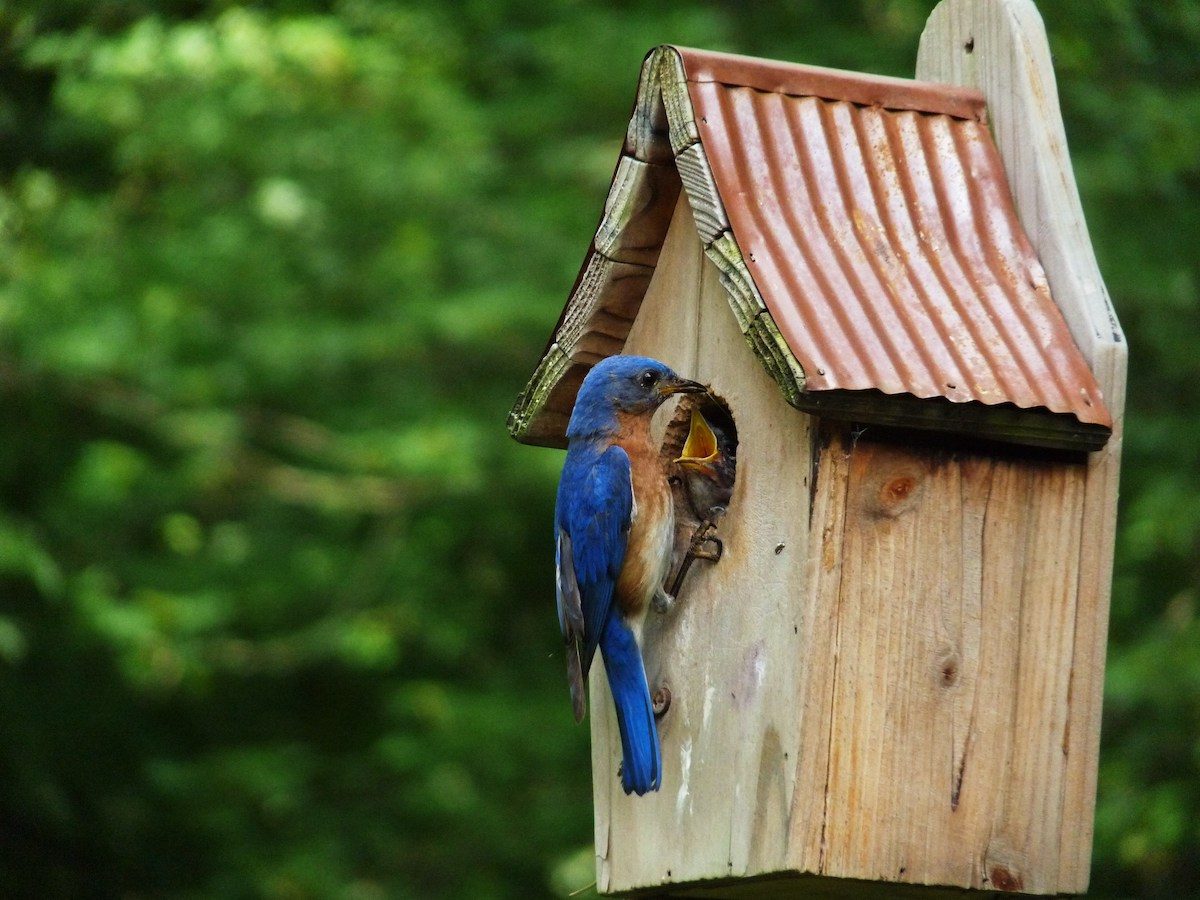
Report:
566,356,708,437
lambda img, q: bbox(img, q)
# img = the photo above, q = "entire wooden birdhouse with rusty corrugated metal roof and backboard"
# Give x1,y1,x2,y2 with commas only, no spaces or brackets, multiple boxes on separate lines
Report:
510,0,1126,898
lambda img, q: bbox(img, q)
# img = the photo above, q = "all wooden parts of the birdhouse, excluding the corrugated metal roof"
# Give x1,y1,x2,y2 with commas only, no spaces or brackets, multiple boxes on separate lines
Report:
535,0,1126,898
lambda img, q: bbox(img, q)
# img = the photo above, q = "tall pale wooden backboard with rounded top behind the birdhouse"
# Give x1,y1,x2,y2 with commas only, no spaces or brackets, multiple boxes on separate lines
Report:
917,0,1128,890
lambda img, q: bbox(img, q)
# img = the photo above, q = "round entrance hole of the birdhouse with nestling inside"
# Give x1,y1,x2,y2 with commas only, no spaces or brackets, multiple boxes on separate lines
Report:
661,392,738,600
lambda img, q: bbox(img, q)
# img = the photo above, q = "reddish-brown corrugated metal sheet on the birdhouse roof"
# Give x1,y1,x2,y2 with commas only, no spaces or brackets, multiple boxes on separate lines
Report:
680,50,1111,427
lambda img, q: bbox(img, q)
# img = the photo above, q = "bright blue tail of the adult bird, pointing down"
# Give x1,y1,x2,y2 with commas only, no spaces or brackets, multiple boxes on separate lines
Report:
600,610,662,796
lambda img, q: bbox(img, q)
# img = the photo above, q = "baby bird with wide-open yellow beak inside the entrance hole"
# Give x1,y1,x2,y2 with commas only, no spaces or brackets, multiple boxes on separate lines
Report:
660,408,737,612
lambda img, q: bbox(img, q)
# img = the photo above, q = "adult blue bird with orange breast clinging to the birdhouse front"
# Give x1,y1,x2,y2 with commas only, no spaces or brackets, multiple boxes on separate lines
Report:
554,356,707,796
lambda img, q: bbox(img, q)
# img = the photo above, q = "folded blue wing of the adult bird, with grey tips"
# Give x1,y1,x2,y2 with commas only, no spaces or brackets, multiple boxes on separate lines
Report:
556,446,634,716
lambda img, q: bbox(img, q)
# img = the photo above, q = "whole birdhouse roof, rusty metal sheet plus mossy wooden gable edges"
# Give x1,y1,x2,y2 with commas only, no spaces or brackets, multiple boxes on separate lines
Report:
510,47,1112,450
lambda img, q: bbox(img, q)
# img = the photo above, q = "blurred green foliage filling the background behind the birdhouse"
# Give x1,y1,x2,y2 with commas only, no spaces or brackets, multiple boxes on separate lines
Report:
0,0,1200,898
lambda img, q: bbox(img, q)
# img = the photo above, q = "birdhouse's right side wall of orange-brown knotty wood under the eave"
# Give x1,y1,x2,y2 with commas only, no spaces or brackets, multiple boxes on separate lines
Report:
792,434,1087,893
